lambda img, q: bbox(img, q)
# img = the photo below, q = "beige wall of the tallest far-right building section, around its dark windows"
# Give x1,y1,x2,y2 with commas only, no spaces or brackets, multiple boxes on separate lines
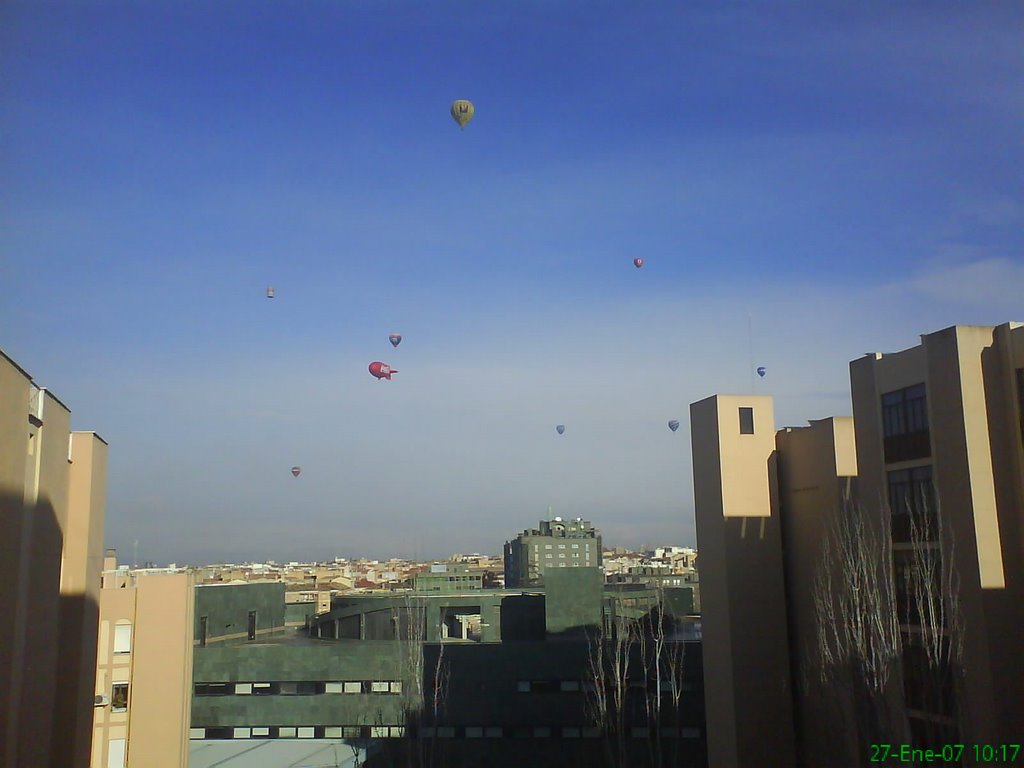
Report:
850,324,1024,743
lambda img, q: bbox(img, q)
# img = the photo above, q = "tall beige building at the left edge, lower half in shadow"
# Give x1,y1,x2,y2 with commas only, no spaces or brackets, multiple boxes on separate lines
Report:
0,351,106,768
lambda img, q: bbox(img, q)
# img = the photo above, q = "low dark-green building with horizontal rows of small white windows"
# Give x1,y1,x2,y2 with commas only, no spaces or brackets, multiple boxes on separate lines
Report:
190,567,707,767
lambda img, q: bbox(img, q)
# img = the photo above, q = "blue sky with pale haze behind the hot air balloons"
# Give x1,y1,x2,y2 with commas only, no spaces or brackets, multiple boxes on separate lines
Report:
0,0,1024,562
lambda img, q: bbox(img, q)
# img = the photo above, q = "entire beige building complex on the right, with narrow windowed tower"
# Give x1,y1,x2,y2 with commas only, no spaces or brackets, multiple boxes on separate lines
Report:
691,324,1024,768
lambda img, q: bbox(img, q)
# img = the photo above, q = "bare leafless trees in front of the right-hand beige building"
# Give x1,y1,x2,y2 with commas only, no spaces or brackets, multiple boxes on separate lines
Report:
814,493,963,761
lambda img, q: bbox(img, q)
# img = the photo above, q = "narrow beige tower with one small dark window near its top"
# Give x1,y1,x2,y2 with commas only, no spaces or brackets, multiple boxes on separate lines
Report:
690,395,795,768
